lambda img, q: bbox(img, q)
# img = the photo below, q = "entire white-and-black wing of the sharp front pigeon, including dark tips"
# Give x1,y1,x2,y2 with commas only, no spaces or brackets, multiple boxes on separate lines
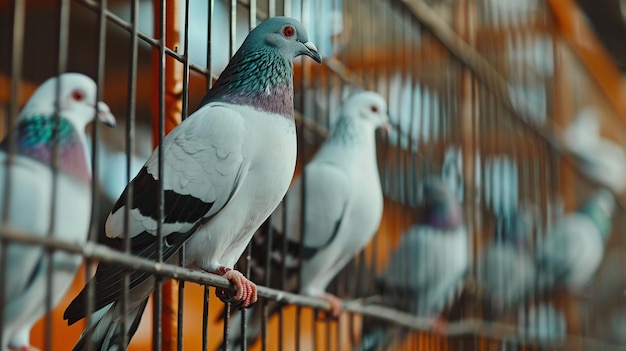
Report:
64,103,247,324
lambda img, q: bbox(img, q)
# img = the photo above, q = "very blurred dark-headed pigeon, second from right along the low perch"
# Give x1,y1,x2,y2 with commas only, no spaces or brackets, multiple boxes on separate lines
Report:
478,205,539,314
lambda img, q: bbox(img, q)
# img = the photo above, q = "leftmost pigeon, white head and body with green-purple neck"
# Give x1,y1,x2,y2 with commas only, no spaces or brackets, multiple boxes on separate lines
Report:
0,73,115,350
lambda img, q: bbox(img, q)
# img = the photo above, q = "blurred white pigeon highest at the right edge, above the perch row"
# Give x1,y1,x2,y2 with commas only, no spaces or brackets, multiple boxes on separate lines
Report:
561,108,626,194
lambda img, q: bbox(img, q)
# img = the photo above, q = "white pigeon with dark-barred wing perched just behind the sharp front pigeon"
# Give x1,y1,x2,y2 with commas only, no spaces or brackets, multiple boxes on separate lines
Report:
228,91,389,349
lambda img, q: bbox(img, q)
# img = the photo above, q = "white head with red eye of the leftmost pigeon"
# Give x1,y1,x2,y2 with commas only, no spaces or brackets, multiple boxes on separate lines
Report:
20,73,115,131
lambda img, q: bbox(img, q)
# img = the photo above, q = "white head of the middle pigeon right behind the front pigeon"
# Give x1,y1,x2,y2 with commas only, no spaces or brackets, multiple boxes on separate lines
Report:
340,90,390,131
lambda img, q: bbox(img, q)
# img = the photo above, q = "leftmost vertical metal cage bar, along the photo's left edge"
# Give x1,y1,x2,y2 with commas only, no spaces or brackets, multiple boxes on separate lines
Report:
0,0,26,346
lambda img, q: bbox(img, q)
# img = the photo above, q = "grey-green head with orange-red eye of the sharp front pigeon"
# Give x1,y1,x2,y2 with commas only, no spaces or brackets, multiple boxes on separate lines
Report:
242,17,322,63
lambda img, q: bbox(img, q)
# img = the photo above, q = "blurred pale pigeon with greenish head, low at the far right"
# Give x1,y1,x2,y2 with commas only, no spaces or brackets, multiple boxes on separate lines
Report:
535,189,615,292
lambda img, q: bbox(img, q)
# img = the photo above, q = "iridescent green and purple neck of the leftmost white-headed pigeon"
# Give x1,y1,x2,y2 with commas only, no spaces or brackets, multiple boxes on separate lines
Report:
1,116,91,181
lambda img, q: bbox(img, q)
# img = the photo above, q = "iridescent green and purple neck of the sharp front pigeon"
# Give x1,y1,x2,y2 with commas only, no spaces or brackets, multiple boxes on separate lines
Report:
201,47,293,118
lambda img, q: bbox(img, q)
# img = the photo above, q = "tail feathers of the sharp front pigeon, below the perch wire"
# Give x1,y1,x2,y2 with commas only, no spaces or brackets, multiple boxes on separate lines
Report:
72,298,148,351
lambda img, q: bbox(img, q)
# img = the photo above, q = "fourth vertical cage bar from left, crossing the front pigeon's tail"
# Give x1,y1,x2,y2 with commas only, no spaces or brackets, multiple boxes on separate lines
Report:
120,0,139,349
